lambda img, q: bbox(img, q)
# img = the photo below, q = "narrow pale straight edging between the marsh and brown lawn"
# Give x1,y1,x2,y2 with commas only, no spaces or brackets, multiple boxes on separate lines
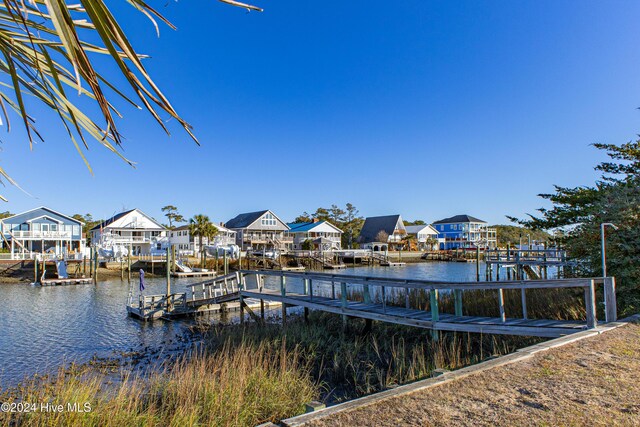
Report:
280,320,640,427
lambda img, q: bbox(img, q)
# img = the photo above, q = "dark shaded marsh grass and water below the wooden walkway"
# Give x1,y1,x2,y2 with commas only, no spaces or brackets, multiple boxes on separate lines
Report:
200,312,540,403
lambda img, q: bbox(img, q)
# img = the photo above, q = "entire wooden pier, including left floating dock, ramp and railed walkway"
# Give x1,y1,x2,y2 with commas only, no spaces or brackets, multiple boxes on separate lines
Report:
127,270,616,337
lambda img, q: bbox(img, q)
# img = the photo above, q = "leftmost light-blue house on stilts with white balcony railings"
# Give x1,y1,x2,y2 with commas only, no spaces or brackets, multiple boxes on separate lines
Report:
0,206,85,259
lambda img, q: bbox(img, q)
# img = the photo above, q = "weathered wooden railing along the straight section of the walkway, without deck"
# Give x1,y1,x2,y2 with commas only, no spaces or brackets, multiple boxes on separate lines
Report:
240,270,617,336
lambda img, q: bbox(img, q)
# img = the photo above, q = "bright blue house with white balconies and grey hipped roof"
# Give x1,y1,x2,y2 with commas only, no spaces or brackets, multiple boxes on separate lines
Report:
433,215,497,250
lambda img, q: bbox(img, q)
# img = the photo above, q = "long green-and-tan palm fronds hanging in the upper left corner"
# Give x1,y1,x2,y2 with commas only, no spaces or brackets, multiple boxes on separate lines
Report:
0,0,262,201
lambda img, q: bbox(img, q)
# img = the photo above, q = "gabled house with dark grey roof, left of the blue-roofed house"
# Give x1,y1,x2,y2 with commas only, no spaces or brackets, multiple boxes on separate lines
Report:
224,210,293,251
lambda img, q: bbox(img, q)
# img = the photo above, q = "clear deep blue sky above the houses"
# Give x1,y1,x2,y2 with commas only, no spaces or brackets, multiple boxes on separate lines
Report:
0,0,640,223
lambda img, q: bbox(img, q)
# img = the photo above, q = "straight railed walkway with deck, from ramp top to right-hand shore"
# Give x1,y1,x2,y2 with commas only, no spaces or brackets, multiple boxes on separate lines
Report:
240,271,616,337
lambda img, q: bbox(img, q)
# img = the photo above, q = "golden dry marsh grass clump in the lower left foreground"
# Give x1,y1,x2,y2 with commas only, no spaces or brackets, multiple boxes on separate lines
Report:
0,344,317,427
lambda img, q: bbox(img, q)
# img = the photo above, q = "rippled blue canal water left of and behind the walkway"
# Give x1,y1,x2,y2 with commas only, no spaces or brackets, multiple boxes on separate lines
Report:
0,262,552,386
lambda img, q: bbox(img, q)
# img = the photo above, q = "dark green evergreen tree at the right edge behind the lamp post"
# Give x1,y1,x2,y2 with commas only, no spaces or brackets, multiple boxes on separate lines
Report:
509,140,640,315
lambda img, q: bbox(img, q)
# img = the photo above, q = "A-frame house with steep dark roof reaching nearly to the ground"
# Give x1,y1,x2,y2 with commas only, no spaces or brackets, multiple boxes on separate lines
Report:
358,215,407,251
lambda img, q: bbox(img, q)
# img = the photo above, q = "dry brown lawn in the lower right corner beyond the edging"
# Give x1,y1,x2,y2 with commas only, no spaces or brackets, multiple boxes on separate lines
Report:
310,324,640,426
